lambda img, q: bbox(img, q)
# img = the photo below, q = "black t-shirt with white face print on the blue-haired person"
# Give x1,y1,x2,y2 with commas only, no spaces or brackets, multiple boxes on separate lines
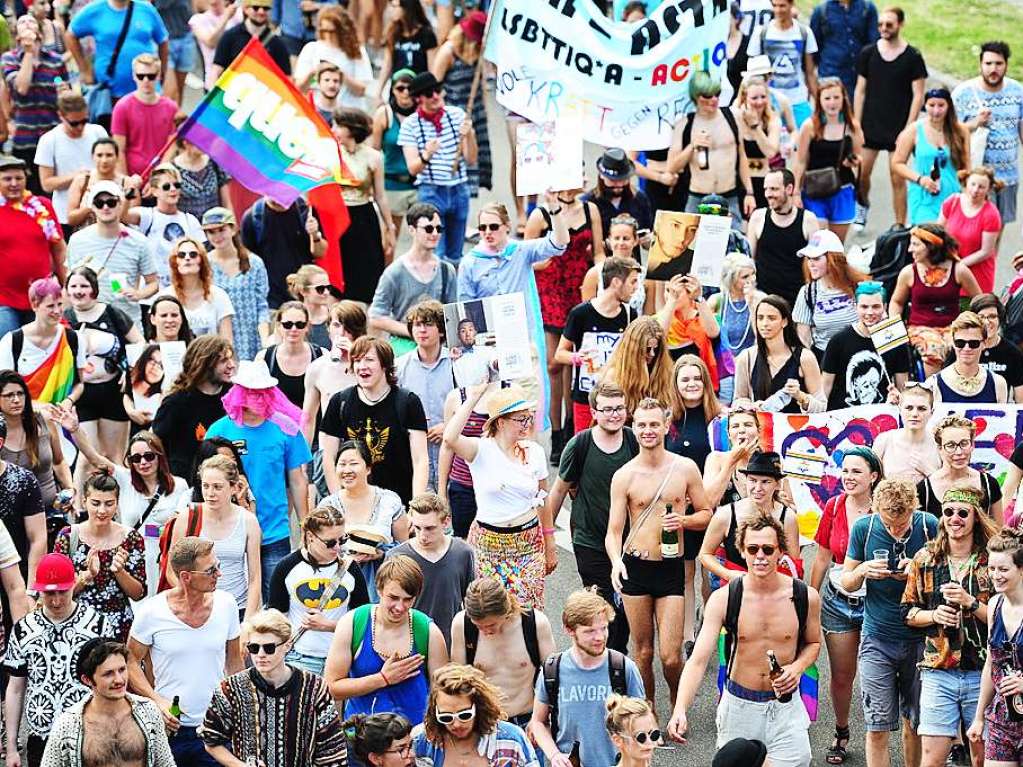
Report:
820,326,909,410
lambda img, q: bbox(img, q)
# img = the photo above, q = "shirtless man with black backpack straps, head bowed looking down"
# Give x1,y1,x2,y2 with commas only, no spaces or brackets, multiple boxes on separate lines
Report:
451,578,555,729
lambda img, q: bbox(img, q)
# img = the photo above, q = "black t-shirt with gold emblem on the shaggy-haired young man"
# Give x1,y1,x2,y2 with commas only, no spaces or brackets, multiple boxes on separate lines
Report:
320,387,427,504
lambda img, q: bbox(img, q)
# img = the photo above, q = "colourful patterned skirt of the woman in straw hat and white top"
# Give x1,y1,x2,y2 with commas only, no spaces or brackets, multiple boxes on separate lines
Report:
468,522,546,610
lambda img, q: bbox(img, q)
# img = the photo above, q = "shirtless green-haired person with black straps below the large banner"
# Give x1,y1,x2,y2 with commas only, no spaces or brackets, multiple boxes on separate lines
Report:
668,72,757,230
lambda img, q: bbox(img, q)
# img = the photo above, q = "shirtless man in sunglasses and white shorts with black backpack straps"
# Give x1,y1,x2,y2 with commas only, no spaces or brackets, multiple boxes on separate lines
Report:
668,516,820,767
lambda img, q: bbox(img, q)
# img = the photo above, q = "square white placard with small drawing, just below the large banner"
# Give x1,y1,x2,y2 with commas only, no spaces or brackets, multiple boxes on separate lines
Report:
515,120,582,197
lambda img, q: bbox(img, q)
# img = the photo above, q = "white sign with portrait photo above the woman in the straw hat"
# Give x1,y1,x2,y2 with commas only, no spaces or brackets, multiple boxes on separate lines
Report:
444,292,533,387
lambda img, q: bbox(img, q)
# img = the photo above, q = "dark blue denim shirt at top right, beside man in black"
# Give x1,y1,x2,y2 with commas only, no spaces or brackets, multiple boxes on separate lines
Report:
810,0,879,88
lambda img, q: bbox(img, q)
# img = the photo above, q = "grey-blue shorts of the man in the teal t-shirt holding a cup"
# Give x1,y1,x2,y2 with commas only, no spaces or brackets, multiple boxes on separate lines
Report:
856,634,924,732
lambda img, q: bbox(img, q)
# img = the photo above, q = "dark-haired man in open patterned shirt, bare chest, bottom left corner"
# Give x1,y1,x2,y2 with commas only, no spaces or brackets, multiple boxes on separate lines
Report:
42,637,175,767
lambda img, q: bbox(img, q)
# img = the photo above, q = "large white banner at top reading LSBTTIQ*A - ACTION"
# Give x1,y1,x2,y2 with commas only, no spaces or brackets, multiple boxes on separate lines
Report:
484,0,729,150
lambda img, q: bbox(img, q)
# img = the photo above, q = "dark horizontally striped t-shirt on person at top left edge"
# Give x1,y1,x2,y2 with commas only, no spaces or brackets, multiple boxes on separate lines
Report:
0,48,68,149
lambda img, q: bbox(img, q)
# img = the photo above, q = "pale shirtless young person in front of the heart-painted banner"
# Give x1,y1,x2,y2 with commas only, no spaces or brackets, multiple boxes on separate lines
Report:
874,384,941,485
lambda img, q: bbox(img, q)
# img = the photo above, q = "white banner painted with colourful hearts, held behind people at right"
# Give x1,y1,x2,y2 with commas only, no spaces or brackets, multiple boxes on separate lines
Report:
712,404,1023,538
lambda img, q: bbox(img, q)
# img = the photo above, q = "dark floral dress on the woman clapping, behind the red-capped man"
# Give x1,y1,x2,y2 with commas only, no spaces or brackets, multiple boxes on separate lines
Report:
53,528,145,642
